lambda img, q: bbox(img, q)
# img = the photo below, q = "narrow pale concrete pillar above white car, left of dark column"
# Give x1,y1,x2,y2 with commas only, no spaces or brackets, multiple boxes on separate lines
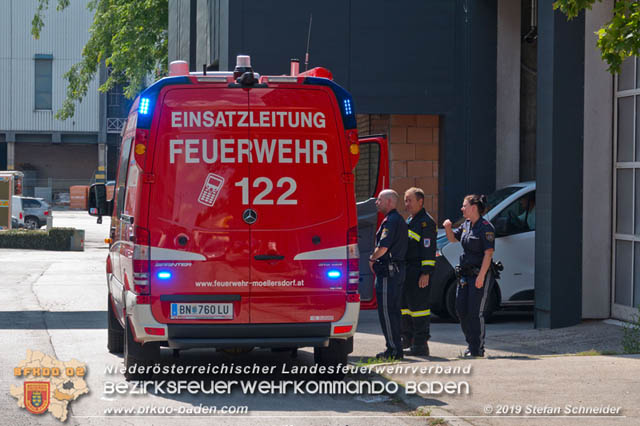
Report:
496,0,521,188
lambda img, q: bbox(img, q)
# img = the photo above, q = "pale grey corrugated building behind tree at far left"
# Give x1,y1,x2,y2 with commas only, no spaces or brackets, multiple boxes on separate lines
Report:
0,0,128,198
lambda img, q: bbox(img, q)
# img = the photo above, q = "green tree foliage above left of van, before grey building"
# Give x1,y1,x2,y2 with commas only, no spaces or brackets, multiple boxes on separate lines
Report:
31,0,169,120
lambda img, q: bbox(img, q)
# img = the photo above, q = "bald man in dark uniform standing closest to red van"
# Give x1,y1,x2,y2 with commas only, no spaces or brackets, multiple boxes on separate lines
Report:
369,189,407,359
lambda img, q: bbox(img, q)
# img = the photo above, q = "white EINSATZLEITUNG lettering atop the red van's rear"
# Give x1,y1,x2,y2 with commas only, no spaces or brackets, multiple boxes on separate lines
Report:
171,111,327,129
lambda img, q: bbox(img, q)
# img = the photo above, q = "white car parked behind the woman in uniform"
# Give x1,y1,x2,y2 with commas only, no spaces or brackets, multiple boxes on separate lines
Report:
431,182,536,318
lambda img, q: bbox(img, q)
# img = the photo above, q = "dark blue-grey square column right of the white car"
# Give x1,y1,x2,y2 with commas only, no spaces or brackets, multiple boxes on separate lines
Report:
534,0,585,328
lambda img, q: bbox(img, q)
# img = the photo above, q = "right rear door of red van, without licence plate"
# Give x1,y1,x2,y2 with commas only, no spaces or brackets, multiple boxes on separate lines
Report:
249,85,355,323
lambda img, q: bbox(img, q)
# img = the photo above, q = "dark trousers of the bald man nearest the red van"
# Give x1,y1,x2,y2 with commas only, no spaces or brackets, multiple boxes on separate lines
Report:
376,266,405,355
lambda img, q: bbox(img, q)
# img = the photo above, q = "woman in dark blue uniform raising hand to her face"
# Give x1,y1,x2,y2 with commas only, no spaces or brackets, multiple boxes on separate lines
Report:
443,195,495,357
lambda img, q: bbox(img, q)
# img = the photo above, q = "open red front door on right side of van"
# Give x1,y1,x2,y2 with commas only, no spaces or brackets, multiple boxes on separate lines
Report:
354,135,389,309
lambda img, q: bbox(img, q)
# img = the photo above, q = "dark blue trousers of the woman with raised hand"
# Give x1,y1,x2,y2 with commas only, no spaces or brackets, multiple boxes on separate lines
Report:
456,270,494,355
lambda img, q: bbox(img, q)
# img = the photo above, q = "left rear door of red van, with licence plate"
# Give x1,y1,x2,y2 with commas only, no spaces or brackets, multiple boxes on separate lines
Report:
149,88,250,323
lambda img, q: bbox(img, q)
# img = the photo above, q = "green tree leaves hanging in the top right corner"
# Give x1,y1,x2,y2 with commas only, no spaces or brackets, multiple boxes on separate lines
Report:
553,0,640,73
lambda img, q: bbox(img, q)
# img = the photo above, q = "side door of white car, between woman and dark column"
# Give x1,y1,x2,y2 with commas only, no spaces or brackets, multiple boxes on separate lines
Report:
491,189,536,304
